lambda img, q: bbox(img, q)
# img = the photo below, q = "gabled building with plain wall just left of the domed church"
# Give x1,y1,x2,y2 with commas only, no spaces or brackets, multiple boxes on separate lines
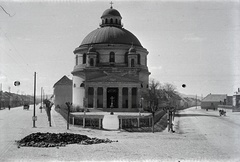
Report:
53,75,72,107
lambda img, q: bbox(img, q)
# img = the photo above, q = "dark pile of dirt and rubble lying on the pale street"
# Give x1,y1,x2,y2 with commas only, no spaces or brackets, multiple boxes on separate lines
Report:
16,132,118,147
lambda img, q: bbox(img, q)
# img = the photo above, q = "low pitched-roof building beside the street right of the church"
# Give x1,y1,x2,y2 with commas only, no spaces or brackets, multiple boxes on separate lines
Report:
201,93,227,110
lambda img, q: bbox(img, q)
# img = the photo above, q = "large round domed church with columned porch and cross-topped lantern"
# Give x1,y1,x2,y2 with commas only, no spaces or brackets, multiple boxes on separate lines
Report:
72,6,150,112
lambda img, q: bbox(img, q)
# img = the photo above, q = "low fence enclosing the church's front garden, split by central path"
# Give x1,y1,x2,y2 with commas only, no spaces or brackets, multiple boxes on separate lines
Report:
55,108,166,129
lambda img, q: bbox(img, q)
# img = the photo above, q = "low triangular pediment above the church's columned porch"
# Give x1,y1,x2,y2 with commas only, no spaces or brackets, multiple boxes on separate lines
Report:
88,74,138,83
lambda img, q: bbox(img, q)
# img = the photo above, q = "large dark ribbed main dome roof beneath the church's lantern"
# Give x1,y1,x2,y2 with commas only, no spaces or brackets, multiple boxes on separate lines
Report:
80,26,142,47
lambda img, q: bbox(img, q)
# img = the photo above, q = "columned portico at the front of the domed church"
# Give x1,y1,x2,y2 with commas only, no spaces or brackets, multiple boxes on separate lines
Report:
85,83,140,111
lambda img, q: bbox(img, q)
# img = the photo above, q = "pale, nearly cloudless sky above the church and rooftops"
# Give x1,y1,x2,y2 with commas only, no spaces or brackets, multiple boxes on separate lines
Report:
0,0,240,96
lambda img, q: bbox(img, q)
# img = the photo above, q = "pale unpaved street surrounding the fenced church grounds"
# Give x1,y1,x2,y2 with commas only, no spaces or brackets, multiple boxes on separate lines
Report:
0,107,240,161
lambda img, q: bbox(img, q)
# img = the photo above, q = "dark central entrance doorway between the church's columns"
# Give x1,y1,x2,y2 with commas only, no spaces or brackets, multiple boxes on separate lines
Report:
107,88,118,108
